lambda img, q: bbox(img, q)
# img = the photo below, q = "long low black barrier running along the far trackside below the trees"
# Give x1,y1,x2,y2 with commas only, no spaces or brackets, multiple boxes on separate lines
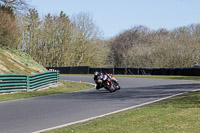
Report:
47,66,200,76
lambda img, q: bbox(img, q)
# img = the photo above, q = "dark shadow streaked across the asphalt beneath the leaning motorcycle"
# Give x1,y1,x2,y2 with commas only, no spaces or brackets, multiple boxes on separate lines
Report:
42,83,200,101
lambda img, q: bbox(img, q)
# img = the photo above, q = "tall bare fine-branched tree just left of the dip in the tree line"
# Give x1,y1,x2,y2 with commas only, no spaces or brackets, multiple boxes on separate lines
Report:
71,13,104,66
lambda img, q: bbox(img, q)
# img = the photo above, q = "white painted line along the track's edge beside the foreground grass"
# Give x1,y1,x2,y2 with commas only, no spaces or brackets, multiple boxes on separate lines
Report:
33,86,200,133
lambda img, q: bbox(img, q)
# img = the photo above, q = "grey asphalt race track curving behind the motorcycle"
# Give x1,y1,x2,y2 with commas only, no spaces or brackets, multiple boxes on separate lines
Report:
0,76,200,133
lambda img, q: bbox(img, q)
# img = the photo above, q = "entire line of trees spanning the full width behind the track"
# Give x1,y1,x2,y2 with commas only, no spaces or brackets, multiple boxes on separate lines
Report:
0,0,200,68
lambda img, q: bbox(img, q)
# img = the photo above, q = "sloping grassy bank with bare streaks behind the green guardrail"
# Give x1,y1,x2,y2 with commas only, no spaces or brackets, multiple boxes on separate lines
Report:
0,46,47,75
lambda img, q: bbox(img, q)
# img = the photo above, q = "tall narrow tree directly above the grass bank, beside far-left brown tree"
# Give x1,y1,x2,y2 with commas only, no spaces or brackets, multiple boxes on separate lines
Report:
17,9,41,57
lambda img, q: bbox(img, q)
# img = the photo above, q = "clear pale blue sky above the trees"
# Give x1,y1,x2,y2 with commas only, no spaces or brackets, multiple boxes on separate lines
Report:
29,0,200,38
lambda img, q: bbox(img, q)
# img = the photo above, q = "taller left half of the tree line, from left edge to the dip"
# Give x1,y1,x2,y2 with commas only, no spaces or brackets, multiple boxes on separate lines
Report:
0,0,108,66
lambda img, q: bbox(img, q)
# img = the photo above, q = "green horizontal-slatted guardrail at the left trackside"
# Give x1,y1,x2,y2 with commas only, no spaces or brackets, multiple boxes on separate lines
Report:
0,71,59,93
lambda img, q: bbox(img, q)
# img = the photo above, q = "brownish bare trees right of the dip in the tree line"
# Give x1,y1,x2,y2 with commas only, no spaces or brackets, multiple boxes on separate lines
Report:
109,24,200,68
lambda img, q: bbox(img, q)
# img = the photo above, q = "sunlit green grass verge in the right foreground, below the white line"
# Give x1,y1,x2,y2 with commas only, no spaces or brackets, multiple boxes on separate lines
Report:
45,92,200,133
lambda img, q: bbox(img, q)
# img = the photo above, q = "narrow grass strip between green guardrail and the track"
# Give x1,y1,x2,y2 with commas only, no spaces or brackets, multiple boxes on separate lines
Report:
0,81,94,102
